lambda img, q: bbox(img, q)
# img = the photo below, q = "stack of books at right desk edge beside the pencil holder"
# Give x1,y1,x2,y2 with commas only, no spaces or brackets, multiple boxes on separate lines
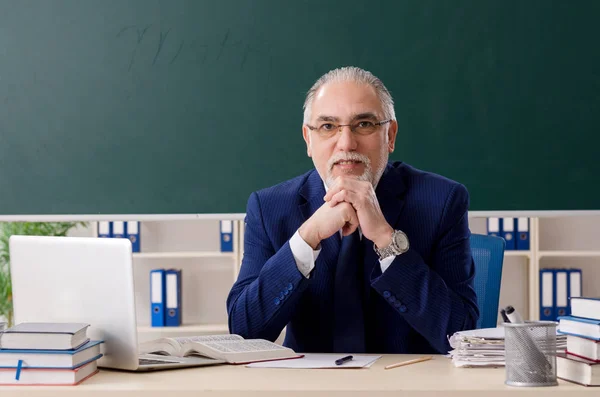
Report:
556,297,600,386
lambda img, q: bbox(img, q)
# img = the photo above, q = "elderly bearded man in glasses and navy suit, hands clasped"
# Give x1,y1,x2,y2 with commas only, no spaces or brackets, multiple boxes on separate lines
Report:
227,67,479,353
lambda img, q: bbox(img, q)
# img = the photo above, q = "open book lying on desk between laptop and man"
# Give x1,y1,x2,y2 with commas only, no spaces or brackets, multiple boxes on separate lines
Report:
140,335,302,364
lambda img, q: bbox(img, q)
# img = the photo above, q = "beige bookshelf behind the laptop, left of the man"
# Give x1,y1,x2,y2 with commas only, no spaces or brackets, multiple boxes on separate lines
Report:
85,217,243,342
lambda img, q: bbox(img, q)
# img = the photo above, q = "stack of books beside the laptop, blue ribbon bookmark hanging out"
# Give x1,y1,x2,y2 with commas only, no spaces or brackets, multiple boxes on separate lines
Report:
0,323,102,385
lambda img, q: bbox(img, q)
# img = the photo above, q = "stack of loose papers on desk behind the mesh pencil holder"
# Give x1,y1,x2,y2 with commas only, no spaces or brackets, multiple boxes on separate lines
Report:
449,327,567,367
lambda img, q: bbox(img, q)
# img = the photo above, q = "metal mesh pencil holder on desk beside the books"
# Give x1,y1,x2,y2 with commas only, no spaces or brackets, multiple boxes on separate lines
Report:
504,321,558,386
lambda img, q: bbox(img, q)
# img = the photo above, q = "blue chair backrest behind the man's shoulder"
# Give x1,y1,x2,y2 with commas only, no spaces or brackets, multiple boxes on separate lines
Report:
471,234,506,328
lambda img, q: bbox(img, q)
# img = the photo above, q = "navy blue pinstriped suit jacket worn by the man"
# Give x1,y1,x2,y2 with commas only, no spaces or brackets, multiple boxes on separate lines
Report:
227,162,479,353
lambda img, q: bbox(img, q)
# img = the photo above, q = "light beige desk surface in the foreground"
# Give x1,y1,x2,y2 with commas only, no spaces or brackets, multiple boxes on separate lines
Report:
0,355,600,397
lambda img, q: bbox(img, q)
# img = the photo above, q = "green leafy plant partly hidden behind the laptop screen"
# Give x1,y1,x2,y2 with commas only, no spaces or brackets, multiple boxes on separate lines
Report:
0,222,87,327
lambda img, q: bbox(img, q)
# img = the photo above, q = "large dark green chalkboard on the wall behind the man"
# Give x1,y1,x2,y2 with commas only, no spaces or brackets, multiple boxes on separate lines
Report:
0,0,600,214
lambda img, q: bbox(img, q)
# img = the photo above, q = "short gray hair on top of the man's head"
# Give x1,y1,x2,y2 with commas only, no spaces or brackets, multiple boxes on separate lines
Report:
304,66,396,124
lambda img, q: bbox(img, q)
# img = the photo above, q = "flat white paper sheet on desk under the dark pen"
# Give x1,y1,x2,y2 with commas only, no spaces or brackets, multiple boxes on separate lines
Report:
246,353,381,369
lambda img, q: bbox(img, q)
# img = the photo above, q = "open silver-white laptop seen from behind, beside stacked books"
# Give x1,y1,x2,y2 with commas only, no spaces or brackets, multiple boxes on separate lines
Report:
9,236,223,371
